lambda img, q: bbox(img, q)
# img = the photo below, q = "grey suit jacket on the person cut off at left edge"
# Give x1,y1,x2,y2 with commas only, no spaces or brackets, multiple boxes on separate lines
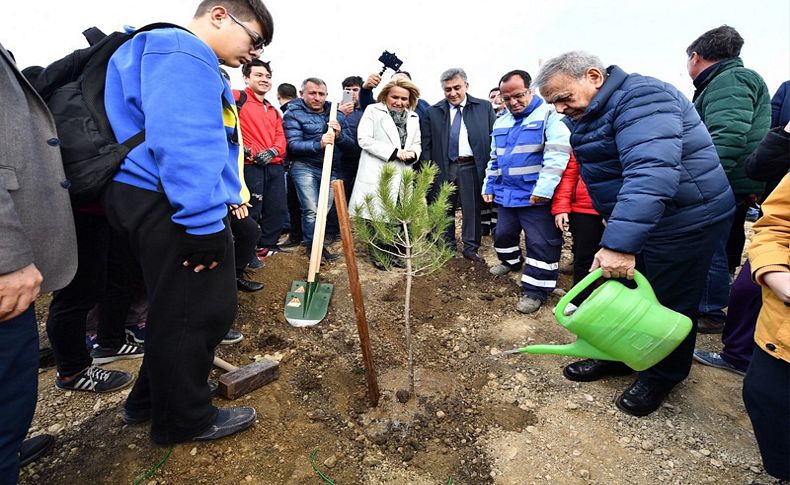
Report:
0,41,77,291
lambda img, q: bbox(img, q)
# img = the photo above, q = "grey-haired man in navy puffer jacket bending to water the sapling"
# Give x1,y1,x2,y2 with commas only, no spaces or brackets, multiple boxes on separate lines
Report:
535,52,734,416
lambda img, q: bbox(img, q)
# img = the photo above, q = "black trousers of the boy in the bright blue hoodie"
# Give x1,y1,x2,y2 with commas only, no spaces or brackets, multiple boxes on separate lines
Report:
105,182,237,444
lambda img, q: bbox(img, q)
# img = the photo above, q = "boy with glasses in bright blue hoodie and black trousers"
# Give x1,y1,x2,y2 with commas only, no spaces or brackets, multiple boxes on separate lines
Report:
105,0,273,444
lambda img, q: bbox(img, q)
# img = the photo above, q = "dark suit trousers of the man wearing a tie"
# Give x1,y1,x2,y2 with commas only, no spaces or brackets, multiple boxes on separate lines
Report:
445,162,483,253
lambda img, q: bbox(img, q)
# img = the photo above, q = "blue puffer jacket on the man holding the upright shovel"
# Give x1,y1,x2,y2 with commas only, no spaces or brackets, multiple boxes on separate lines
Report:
283,99,356,170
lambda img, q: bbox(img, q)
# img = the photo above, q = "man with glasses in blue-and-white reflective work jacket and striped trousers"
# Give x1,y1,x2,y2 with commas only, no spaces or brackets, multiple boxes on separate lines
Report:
483,70,571,313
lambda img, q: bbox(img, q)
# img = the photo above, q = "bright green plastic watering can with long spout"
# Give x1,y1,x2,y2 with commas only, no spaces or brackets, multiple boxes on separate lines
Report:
508,269,691,371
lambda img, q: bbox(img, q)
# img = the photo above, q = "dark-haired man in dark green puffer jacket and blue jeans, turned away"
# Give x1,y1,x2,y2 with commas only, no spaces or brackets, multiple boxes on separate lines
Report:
686,25,771,333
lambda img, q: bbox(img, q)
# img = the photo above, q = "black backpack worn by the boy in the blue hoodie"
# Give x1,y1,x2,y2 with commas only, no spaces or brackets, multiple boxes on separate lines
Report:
22,23,182,205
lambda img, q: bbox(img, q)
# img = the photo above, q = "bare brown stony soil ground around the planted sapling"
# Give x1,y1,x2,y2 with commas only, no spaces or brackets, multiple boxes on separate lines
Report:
20,233,771,485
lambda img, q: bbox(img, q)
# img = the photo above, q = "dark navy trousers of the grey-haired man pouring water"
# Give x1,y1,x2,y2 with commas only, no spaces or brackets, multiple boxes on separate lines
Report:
636,220,730,391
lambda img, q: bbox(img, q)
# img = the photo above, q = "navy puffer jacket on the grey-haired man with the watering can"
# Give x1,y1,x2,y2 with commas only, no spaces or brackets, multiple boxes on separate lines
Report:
564,66,735,254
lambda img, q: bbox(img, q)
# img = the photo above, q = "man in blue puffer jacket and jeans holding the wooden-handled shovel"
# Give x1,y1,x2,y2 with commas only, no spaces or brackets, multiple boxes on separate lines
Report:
283,77,355,260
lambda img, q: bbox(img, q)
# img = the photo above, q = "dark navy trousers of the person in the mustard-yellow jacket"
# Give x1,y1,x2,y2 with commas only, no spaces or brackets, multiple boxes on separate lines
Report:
743,346,790,480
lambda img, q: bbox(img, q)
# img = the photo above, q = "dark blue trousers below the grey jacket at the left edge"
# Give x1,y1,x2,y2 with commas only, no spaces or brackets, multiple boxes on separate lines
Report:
0,305,38,485
